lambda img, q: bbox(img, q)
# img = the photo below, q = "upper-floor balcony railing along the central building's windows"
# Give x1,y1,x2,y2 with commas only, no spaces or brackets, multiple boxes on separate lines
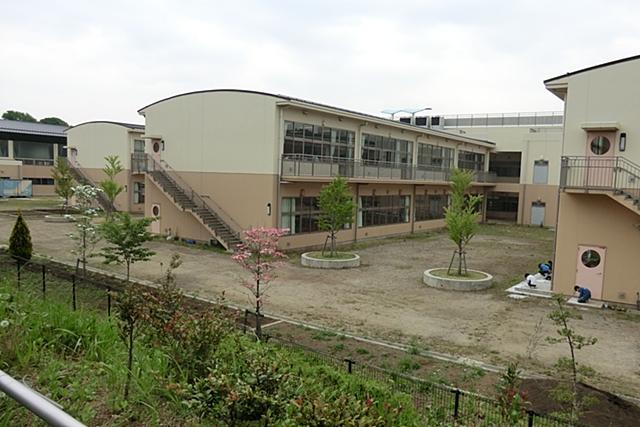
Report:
281,154,496,183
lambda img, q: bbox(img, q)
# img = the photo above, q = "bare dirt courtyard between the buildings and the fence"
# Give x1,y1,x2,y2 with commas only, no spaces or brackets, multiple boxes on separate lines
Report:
0,214,640,397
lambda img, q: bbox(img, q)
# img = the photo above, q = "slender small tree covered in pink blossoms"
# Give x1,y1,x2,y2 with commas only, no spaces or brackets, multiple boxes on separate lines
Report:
231,227,287,339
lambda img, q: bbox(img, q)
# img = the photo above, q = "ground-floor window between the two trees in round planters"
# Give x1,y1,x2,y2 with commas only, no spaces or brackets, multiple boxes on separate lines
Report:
358,196,411,227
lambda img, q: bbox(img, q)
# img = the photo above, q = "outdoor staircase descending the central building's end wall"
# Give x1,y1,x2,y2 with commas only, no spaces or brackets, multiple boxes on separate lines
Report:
139,156,242,251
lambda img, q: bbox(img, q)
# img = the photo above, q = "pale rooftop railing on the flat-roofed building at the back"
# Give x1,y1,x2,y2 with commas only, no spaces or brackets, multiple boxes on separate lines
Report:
444,111,564,128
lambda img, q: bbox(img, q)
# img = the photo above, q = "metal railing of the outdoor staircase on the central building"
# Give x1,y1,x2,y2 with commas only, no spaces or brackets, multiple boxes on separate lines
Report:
131,153,243,240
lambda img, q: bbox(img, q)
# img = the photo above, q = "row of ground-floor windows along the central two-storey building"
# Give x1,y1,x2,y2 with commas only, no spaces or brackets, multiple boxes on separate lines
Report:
280,194,449,234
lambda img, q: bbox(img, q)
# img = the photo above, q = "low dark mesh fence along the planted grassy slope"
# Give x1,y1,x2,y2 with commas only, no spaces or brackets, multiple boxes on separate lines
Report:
0,252,579,427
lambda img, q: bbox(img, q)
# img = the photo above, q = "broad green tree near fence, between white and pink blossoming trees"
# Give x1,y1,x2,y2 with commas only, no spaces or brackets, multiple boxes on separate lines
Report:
100,212,155,282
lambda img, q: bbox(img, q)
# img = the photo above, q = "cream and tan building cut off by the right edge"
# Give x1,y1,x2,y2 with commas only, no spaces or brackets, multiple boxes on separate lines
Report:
544,56,640,304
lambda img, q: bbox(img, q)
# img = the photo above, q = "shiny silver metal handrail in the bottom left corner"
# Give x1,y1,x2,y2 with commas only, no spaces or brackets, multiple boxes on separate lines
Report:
0,370,86,427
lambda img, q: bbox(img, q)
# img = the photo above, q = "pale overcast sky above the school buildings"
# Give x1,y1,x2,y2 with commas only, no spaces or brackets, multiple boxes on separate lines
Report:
0,0,640,123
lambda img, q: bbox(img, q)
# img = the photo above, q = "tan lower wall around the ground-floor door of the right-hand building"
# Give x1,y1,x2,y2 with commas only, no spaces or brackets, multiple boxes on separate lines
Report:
553,193,640,304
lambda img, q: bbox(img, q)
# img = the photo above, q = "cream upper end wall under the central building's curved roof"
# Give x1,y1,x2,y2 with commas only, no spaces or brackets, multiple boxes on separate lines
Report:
141,92,280,175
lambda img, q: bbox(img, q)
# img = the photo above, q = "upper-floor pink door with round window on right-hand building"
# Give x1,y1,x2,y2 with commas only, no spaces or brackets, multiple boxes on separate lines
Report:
585,132,616,188
